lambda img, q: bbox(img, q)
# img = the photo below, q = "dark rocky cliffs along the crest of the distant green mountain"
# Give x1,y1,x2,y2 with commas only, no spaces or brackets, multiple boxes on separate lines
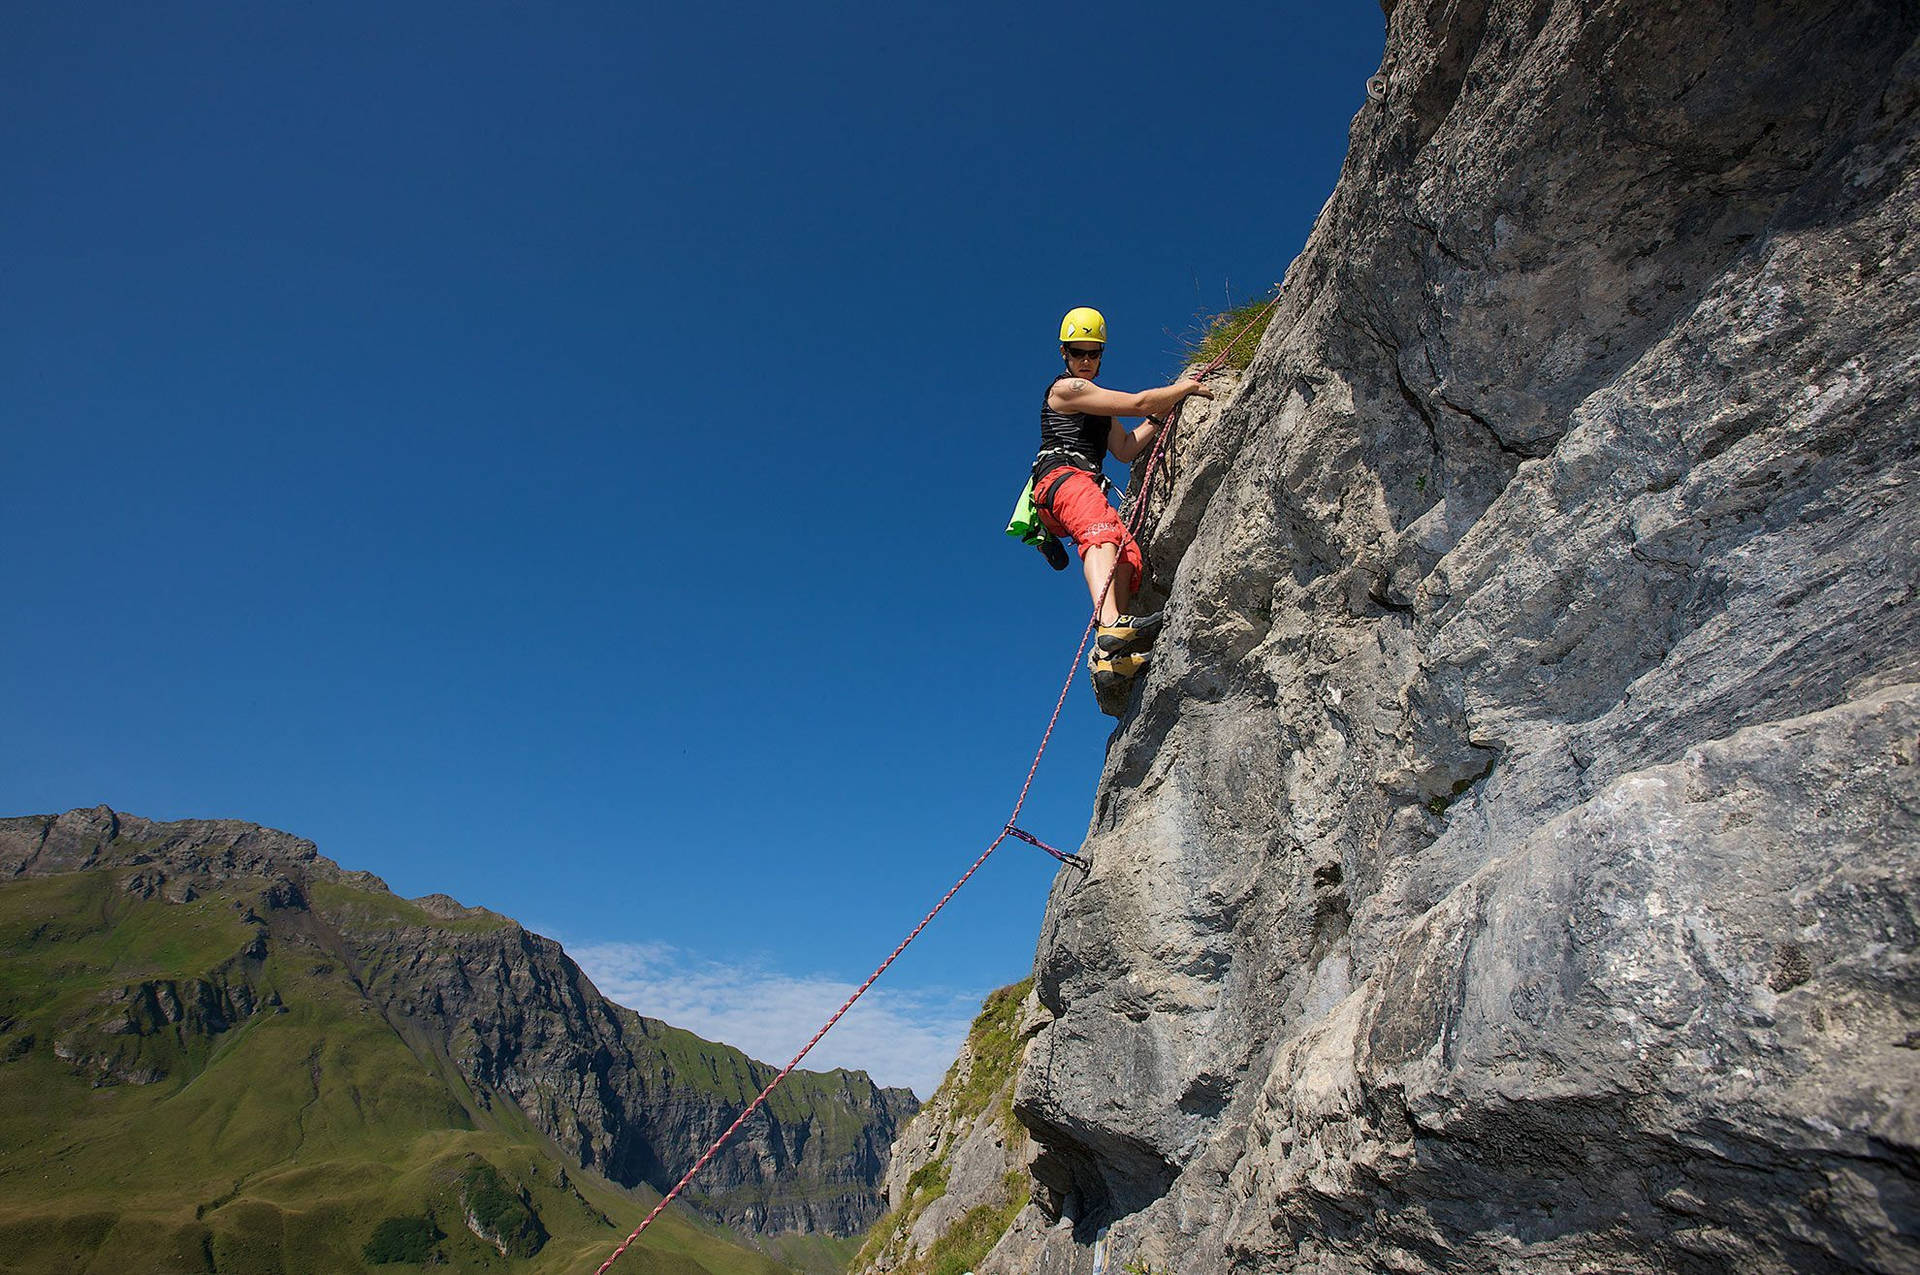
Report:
0,806,918,1242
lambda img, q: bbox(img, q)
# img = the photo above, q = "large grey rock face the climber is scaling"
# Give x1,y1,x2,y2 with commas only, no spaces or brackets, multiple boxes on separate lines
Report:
879,0,1920,1275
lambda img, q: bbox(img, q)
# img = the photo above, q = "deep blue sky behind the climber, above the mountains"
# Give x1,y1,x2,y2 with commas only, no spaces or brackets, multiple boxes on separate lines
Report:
0,0,1380,1095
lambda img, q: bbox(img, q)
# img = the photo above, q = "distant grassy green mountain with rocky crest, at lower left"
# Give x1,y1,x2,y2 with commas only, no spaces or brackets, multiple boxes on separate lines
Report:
0,812,913,1275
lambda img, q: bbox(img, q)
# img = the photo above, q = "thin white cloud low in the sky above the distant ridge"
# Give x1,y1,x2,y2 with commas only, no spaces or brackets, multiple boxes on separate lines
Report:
566,943,985,1100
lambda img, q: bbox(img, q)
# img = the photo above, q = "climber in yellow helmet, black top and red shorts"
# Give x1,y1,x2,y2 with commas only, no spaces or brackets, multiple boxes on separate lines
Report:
1033,305,1213,716
